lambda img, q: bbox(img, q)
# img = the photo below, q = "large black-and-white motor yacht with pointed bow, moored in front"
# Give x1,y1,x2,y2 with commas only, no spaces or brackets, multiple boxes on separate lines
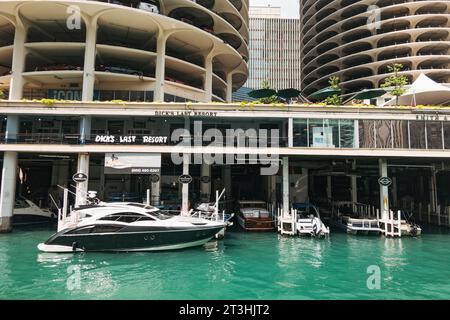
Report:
38,202,226,252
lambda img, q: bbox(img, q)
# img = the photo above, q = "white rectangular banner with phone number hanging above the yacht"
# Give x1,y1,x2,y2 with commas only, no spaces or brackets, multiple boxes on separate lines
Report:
105,153,161,175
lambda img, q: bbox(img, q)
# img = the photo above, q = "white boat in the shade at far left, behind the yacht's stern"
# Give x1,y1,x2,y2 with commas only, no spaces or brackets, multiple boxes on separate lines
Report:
12,197,57,226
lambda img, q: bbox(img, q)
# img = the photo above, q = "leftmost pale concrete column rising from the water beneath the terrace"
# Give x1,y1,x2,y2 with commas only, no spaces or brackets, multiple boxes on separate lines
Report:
0,115,19,233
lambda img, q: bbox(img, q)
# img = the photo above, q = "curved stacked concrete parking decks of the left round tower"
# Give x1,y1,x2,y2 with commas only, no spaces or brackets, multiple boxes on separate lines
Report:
0,0,248,101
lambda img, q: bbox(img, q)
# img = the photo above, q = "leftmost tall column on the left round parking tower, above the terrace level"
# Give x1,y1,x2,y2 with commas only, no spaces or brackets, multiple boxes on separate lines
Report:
9,23,27,100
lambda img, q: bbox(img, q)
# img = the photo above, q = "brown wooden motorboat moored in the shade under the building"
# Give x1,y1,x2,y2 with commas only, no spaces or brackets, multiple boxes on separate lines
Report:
237,201,275,231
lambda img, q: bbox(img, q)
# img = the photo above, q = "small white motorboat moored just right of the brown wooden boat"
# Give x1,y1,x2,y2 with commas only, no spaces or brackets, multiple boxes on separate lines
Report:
292,203,330,237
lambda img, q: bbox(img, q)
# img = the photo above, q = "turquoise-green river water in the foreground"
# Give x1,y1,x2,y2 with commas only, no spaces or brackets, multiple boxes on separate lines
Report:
0,228,450,300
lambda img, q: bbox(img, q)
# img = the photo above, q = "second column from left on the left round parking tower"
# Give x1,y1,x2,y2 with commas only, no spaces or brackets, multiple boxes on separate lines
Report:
82,19,97,101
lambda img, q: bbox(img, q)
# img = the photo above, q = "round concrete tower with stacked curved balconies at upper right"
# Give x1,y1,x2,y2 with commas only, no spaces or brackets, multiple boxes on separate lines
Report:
300,0,450,95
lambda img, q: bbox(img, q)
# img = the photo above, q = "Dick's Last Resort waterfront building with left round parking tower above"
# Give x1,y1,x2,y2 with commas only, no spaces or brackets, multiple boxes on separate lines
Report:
0,0,450,235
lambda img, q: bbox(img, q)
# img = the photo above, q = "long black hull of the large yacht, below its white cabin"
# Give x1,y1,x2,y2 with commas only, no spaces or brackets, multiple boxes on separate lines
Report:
38,226,223,252
